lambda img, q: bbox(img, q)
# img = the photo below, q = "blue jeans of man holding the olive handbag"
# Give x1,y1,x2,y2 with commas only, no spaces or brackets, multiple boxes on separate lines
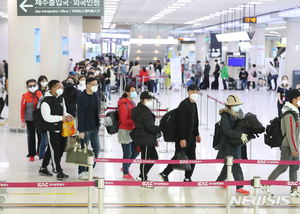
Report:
78,128,100,174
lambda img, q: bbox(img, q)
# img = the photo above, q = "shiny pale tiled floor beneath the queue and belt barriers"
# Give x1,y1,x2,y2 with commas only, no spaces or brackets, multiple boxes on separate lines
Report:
0,79,300,214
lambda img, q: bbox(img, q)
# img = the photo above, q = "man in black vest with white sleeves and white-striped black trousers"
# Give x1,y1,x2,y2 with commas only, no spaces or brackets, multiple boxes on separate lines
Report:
39,80,73,180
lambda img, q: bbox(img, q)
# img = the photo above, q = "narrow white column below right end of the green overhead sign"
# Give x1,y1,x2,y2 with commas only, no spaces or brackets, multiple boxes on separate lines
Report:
69,16,83,66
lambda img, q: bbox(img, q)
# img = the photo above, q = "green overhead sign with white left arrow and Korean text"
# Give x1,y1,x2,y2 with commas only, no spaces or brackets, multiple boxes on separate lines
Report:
14,0,104,16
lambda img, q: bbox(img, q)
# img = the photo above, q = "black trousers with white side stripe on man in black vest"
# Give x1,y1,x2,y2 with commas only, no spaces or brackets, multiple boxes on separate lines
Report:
42,131,62,172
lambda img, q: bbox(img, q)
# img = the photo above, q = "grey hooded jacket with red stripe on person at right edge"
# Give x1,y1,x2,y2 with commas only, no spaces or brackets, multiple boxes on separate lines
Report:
281,102,299,152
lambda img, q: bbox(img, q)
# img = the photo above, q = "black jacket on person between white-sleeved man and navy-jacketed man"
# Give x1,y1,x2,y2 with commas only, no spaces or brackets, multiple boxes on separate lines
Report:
63,87,81,117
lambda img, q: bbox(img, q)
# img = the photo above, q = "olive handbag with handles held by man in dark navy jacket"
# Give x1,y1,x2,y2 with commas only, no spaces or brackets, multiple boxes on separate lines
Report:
66,137,95,166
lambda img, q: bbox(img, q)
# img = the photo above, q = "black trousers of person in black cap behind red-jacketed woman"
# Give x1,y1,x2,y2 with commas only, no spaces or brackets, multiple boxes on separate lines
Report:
139,146,158,181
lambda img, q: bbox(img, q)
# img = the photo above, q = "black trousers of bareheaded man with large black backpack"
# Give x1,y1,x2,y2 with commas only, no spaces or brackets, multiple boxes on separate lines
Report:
163,140,196,179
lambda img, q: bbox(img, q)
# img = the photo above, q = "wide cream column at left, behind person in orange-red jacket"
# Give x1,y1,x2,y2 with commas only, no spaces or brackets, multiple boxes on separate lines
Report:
7,1,40,128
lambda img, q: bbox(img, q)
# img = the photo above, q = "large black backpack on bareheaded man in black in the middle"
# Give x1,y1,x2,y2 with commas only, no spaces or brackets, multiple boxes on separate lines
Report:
159,108,178,142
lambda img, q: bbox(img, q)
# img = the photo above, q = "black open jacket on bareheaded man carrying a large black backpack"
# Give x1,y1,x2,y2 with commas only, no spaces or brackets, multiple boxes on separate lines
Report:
177,98,199,144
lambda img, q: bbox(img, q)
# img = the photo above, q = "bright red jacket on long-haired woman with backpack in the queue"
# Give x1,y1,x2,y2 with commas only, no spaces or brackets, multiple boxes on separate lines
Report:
118,98,135,130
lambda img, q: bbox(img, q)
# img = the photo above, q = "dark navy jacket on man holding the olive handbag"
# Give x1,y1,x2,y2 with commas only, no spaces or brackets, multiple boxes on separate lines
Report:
77,90,100,132
